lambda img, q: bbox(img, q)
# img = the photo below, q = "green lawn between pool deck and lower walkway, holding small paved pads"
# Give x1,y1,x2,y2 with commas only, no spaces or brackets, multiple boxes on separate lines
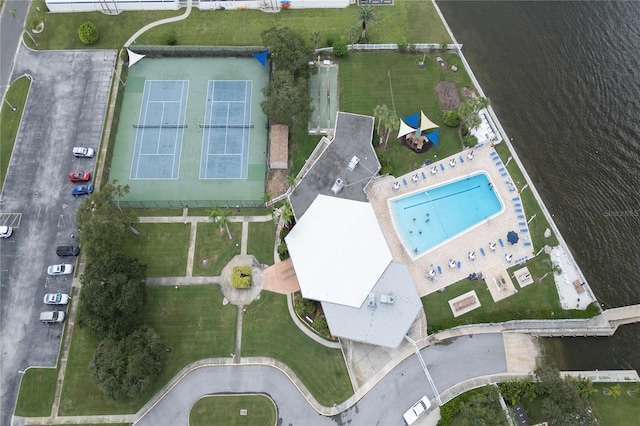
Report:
422,255,599,334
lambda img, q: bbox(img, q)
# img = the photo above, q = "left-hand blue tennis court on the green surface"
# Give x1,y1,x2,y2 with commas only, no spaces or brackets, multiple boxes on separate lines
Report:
130,80,189,179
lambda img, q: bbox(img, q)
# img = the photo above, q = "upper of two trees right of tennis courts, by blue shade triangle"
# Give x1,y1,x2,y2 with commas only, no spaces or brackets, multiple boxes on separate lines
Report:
262,27,313,80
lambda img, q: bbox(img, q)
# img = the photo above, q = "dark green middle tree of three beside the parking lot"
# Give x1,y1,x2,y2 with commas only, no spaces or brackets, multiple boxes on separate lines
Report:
78,253,147,338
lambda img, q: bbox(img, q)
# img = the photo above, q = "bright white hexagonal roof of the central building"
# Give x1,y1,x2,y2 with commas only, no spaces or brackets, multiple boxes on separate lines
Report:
285,195,391,308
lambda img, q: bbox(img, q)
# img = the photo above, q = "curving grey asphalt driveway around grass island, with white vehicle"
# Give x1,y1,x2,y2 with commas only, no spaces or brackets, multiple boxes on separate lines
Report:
136,334,507,426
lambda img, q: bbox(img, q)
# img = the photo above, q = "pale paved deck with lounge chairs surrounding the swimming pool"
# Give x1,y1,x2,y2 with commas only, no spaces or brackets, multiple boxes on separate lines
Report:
367,145,534,297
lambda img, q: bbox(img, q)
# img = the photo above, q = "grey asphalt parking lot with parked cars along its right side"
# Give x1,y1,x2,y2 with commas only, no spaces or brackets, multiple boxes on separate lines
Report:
0,46,115,425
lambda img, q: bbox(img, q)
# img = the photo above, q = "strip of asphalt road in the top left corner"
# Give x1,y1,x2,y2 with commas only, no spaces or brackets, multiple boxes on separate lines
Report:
0,0,31,91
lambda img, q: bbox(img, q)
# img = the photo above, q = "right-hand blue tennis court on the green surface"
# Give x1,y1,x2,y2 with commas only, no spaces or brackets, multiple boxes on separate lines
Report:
200,80,252,179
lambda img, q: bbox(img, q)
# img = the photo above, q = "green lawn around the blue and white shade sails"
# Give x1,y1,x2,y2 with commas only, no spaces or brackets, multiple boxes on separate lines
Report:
338,52,472,176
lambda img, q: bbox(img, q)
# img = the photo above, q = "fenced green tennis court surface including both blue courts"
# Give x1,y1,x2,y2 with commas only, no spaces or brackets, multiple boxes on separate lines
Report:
109,58,269,208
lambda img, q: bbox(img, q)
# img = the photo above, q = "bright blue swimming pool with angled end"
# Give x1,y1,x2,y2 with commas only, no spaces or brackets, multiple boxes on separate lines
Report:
389,172,503,258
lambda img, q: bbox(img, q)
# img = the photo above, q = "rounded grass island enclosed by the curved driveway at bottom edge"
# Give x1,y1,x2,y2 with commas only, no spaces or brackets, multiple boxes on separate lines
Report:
189,395,276,426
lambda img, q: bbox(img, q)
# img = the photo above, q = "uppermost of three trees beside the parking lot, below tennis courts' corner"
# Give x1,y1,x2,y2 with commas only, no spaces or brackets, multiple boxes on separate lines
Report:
77,182,138,262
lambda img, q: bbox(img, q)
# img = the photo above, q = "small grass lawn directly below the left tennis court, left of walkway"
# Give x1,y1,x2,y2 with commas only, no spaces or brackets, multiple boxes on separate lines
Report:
122,223,191,277
